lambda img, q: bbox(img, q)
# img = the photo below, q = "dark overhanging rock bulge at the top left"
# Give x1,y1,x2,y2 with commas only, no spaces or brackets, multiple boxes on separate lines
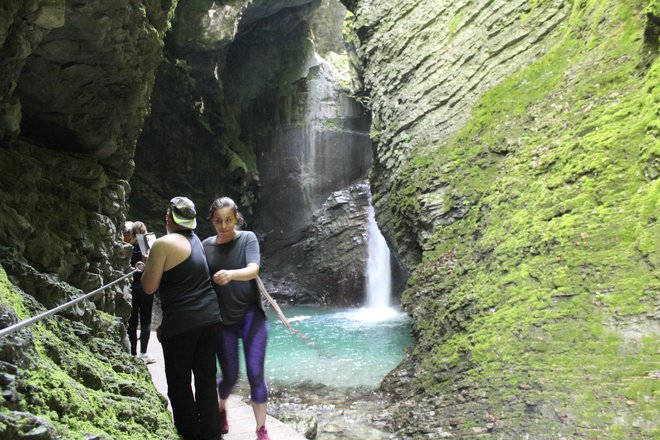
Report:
5,0,166,172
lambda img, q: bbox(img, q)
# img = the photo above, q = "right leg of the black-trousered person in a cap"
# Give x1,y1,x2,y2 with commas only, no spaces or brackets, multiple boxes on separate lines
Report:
193,325,220,440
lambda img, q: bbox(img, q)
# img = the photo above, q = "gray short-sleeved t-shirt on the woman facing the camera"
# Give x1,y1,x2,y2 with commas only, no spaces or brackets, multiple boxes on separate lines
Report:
202,231,261,325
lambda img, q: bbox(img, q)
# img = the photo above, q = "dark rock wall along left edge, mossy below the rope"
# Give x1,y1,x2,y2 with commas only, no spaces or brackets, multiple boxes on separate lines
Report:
0,0,180,439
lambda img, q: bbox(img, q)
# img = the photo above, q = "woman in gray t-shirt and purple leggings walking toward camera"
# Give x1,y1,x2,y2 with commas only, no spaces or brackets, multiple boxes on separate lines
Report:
203,197,269,440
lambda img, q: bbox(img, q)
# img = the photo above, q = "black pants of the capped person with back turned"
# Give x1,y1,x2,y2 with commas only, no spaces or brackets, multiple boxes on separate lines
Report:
162,324,221,440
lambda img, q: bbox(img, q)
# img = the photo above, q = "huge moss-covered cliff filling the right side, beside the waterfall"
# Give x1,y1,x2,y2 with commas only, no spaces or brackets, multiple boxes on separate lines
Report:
345,0,660,439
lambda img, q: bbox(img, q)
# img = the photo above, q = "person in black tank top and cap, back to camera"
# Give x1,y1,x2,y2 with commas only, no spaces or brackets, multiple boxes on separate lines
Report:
141,197,222,440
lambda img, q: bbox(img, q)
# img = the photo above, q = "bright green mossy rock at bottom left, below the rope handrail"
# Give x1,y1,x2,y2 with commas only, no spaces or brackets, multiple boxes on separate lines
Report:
20,322,176,439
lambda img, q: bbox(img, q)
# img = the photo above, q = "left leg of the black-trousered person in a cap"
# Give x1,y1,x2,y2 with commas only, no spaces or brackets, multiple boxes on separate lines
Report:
162,330,200,440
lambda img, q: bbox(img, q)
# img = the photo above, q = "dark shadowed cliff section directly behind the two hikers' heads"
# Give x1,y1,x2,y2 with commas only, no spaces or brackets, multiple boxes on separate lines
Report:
130,1,264,238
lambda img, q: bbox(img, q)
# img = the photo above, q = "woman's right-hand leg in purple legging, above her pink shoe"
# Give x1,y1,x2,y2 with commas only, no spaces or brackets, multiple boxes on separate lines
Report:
241,309,268,429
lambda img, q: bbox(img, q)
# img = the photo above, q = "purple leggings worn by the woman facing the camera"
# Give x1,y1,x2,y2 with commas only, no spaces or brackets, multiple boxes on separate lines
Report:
217,307,268,403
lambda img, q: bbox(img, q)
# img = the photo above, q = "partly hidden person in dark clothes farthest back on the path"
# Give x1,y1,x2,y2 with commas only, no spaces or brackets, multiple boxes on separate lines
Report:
127,222,156,364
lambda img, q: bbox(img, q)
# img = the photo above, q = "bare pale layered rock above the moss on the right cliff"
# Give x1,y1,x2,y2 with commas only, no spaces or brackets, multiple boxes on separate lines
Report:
346,0,570,266
